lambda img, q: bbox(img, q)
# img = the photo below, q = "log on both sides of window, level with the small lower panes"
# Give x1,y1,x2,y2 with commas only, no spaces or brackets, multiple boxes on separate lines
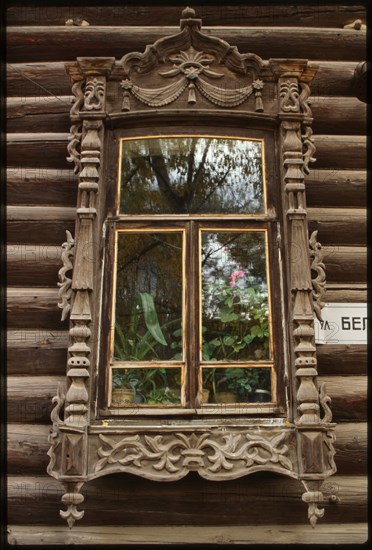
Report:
8,376,367,424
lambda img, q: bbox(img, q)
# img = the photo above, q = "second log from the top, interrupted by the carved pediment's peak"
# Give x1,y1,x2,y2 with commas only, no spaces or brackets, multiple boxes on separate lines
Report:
7,24,366,63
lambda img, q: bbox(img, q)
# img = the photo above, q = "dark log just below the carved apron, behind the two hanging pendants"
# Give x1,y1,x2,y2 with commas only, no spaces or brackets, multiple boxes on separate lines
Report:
8,473,367,532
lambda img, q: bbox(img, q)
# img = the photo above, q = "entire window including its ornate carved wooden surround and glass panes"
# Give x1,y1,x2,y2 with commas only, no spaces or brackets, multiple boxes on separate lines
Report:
48,8,336,527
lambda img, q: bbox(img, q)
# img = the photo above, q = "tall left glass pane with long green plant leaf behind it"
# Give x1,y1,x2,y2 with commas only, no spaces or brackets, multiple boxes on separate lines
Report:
113,232,182,361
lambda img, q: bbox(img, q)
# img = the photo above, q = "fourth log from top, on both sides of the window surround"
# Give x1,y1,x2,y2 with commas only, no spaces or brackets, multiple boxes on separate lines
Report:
7,95,367,135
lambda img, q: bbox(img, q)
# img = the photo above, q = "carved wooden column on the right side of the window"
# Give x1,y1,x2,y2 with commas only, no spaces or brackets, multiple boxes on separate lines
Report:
278,74,320,424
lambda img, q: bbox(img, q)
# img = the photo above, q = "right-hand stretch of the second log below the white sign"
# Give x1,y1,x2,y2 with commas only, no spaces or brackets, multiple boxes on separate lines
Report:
319,376,367,422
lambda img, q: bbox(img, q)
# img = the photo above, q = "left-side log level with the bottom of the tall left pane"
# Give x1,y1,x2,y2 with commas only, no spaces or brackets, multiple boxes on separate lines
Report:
7,330,68,376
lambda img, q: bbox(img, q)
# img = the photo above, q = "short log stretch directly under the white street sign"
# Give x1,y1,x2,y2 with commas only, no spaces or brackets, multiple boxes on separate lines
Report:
317,344,368,376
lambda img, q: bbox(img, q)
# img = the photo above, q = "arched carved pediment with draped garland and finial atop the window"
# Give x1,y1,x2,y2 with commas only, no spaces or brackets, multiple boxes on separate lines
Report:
118,8,264,111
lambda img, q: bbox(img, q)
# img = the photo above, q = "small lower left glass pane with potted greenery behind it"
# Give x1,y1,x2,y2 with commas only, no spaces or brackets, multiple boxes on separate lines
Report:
111,367,181,407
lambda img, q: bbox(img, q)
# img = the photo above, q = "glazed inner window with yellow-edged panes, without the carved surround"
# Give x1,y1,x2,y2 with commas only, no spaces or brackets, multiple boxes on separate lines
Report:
102,133,284,414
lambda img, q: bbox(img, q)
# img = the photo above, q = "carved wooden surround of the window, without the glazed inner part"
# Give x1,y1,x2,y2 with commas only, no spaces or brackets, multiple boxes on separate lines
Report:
48,8,336,527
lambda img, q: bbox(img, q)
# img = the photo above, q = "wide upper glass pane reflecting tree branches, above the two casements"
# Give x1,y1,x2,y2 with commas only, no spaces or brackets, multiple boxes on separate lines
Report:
120,137,265,214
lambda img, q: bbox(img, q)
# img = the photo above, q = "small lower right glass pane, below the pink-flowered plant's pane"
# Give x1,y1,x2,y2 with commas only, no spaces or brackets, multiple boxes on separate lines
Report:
202,367,271,405
